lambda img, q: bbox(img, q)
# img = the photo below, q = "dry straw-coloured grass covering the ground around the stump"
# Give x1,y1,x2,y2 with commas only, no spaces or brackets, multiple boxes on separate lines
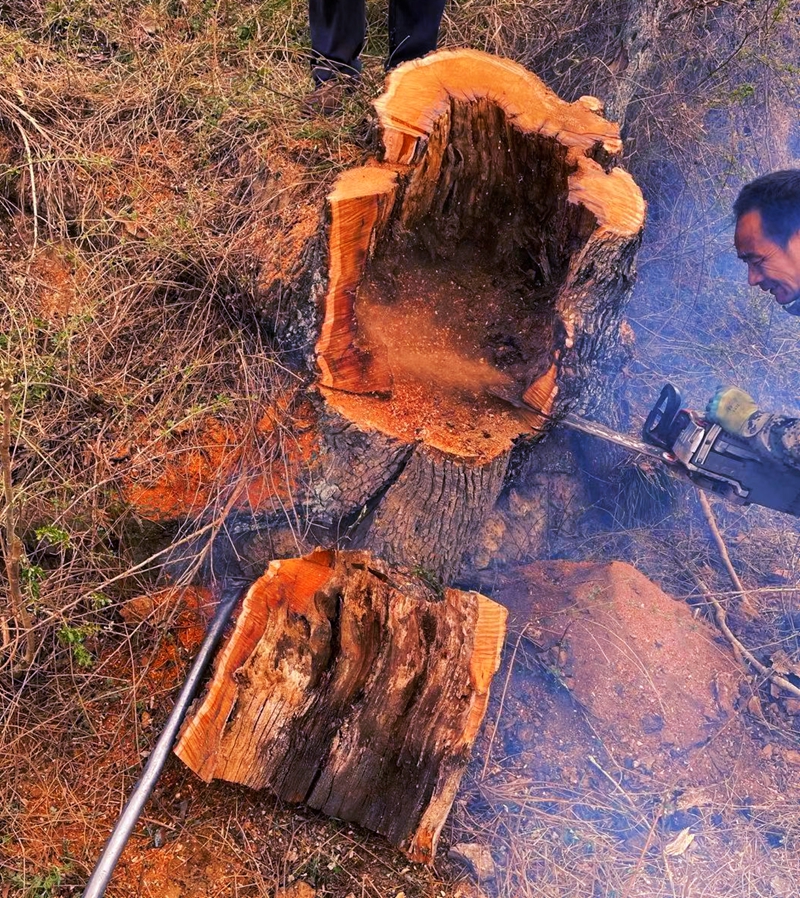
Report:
0,0,798,898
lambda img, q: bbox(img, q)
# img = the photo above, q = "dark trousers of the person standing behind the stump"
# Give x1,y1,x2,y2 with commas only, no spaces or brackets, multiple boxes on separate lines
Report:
308,0,446,82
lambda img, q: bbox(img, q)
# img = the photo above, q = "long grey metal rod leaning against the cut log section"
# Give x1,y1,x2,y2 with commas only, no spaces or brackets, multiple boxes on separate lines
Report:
83,583,249,898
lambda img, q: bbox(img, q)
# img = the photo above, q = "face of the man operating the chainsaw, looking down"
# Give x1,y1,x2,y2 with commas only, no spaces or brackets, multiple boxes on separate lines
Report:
733,210,800,315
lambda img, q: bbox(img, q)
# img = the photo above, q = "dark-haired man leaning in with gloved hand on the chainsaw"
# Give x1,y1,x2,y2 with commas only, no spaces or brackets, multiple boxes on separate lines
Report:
706,169,800,467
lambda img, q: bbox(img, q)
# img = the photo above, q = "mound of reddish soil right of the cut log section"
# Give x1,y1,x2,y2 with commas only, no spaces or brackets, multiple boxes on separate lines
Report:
495,561,744,782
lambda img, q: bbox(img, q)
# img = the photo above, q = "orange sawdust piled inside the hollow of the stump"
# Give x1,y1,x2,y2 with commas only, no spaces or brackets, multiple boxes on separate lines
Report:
324,245,554,460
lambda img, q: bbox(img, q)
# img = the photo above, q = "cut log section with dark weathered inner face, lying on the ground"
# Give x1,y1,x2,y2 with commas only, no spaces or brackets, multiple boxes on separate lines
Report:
176,550,506,862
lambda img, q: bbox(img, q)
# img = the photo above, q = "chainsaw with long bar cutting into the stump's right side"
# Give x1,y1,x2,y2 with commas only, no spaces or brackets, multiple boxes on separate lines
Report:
561,383,800,517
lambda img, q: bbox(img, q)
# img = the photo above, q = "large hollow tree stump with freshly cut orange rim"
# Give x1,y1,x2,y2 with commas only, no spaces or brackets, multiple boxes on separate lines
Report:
306,50,644,581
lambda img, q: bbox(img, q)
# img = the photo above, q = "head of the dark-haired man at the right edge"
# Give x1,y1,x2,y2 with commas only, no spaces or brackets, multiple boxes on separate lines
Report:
733,169,800,315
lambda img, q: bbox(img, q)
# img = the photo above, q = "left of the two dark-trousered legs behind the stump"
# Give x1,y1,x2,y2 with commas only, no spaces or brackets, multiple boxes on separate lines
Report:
308,0,366,84
